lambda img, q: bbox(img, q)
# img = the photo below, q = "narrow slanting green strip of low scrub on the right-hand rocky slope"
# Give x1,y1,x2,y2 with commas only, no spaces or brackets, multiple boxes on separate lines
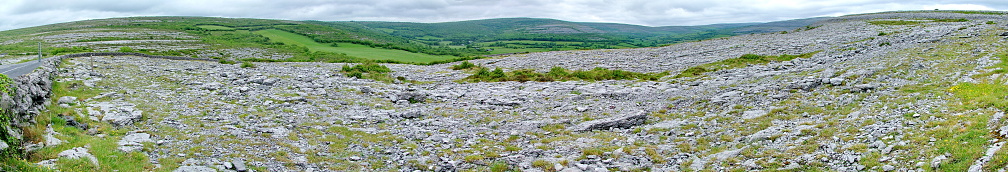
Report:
673,51,820,78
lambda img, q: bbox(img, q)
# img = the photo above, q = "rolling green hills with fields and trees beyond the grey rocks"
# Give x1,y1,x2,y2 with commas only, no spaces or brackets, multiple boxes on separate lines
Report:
0,16,821,63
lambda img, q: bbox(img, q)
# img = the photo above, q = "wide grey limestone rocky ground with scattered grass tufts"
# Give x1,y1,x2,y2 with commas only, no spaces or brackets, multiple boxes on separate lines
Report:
35,13,1008,171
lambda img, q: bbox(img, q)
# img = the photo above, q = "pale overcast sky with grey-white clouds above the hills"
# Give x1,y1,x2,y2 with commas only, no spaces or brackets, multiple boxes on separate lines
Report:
0,0,1008,30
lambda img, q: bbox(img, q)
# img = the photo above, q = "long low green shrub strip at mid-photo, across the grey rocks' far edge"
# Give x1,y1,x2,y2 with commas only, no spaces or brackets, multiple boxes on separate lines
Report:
462,66,668,81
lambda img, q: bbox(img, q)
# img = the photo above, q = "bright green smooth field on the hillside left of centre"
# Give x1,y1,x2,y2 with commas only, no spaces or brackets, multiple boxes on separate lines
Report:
255,29,456,62
